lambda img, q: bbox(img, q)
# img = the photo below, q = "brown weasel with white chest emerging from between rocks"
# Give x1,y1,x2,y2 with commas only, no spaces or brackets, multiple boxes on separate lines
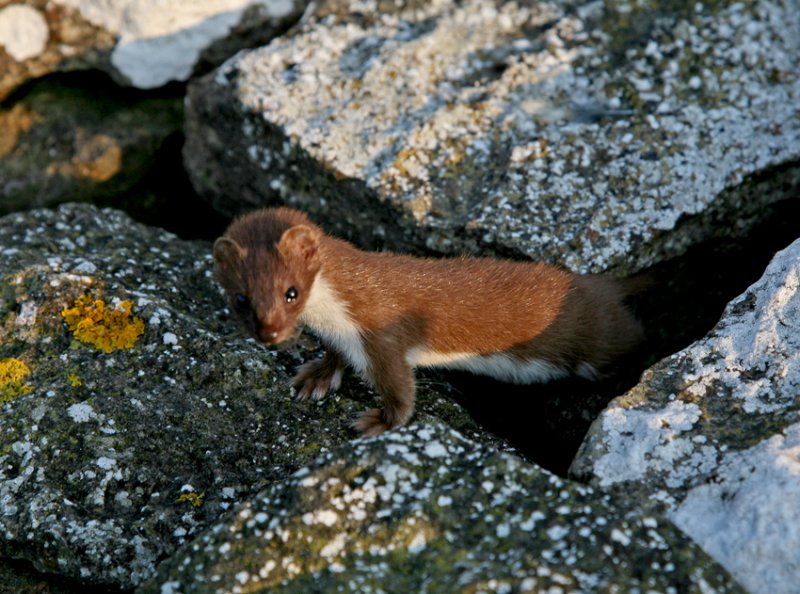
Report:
214,208,643,435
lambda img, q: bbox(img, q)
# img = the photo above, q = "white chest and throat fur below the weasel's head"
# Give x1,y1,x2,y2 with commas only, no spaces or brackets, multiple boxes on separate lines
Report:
300,272,367,374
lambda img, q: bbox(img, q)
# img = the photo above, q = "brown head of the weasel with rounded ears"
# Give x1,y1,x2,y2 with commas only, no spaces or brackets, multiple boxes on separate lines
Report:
214,209,322,345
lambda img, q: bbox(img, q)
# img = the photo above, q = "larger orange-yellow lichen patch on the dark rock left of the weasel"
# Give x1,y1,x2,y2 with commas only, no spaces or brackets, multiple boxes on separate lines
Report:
61,293,144,353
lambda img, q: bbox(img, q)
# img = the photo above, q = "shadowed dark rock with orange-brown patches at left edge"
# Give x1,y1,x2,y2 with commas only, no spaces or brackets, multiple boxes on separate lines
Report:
0,76,183,214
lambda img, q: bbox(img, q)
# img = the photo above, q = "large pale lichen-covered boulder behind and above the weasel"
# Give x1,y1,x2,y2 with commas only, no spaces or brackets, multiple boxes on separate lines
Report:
184,0,800,271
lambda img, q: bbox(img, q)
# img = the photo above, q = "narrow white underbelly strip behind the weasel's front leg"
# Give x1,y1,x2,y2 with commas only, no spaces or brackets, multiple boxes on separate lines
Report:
406,348,569,384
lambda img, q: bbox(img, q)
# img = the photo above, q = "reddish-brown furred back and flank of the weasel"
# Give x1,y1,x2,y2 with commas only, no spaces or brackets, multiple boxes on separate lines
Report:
318,239,641,368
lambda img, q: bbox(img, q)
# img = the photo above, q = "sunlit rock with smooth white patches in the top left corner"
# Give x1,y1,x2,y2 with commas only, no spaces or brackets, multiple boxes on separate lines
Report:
0,0,306,100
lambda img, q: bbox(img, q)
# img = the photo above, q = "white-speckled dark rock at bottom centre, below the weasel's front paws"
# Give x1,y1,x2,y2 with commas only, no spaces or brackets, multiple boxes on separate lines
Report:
139,424,740,594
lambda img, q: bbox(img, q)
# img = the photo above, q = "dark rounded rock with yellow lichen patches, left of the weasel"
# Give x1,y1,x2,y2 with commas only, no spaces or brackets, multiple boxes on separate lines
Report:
0,204,489,588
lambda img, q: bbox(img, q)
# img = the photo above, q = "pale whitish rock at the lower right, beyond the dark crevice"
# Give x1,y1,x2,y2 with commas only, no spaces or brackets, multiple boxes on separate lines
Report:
572,240,800,594
